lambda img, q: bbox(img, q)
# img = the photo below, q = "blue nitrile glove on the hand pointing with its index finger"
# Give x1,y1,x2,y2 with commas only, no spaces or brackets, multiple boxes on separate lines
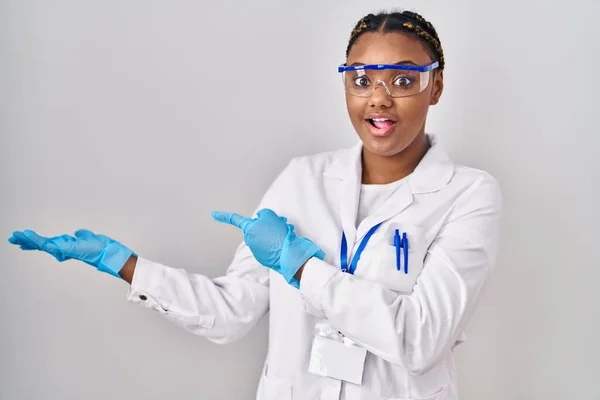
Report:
211,208,325,288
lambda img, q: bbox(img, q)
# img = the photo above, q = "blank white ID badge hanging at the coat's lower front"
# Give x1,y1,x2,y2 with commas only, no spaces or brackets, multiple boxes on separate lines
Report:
308,324,367,385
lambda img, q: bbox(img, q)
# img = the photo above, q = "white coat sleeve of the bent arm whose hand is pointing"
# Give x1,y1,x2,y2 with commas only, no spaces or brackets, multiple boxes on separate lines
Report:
300,175,502,375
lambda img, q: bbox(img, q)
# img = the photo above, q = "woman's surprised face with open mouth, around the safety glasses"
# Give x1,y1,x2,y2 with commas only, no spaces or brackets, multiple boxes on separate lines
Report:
346,32,443,156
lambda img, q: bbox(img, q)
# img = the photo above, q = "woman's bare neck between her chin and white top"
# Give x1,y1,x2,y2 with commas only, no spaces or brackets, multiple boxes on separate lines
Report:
362,134,427,185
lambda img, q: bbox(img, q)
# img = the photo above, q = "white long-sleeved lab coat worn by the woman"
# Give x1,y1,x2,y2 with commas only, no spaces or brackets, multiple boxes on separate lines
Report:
128,136,502,400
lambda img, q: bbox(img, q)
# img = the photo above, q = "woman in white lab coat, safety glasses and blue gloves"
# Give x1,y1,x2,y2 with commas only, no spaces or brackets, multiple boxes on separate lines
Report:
9,12,501,400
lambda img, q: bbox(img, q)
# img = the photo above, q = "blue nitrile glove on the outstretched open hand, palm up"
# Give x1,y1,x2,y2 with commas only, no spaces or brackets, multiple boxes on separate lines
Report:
8,229,135,278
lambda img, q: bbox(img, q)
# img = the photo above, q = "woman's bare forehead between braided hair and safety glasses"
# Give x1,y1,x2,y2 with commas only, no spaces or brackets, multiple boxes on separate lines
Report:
347,32,433,65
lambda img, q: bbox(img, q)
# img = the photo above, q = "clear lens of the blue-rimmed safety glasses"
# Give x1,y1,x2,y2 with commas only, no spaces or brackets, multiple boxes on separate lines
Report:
343,69,431,97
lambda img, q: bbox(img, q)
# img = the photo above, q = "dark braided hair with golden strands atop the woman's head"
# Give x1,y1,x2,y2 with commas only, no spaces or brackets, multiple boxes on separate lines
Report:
346,11,445,71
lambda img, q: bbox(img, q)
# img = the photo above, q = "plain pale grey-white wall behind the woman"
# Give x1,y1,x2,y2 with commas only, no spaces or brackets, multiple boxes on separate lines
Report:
0,0,600,400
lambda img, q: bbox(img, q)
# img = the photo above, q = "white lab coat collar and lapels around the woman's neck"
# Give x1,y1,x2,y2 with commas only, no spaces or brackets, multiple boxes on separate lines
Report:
324,135,454,243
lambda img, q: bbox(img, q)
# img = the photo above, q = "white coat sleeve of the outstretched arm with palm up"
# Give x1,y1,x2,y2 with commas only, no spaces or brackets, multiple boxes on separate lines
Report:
128,160,293,343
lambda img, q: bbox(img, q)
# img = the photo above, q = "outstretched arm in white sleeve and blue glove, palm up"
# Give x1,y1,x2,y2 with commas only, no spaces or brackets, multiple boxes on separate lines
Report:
9,161,298,343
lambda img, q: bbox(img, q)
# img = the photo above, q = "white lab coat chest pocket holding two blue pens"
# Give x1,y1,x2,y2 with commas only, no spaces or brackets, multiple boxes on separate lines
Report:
363,224,425,294
